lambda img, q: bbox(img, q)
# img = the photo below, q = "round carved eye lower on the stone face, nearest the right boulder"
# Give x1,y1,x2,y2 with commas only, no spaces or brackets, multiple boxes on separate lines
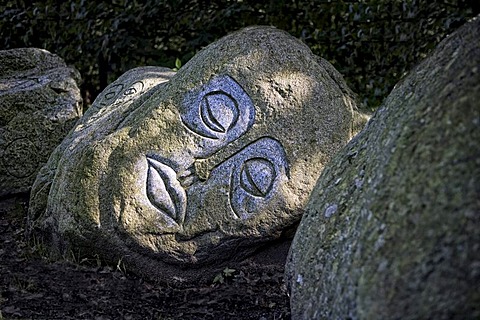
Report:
240,158,276,197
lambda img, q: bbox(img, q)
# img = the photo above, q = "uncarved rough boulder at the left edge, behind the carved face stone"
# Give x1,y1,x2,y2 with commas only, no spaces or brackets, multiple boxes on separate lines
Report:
0,48,82,197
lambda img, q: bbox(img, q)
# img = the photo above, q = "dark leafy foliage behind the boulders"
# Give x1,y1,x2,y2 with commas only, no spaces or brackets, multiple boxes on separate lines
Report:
0,0,480,109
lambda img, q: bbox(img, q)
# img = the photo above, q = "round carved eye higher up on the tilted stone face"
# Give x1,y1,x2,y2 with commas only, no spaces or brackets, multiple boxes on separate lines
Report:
200,91,238,133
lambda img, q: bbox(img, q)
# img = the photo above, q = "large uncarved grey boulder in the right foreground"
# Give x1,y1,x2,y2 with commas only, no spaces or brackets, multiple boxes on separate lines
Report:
286,17,480,319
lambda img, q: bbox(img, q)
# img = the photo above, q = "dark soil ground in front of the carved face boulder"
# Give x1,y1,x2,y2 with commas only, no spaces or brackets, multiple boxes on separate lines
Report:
0,198,290,320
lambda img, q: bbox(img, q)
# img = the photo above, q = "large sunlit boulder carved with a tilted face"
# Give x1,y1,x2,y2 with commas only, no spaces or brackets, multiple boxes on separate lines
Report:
29,27,365,284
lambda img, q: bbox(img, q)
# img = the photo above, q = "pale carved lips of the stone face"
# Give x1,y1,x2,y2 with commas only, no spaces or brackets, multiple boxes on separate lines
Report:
146,157,187,225
